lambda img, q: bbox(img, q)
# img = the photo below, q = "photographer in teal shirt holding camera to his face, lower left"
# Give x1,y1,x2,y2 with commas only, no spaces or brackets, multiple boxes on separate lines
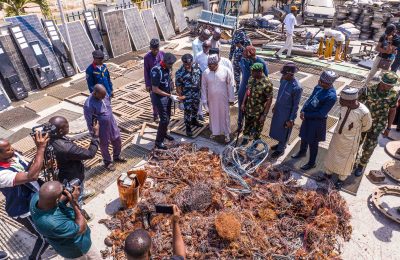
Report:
30,181,101,260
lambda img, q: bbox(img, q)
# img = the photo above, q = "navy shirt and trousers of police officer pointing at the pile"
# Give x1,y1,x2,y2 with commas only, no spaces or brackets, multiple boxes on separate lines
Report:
150,65,172,144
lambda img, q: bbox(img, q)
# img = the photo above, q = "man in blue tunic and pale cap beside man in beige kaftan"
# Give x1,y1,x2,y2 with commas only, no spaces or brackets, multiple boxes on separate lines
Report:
292,71,338,171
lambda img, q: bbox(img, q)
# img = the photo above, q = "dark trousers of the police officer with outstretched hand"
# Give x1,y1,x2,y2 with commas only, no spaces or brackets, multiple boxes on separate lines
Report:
154,95,172,144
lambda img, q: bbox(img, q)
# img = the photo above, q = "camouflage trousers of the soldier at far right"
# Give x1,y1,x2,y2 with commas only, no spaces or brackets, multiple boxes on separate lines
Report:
358,127,383,167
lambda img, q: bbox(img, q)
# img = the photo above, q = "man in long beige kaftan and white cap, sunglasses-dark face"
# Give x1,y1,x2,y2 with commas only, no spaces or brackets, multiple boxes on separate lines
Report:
320,86,372,189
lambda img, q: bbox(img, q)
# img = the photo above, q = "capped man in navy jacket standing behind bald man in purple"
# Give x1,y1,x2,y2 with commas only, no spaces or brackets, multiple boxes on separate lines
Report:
86,50,114,97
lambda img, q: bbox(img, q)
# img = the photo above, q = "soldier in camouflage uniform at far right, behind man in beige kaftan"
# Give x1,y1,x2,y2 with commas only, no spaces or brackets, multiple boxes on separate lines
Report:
354,72,398,176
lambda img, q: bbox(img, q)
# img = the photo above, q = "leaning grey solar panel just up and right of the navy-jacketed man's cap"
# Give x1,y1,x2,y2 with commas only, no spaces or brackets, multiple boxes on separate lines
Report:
104,10,132,58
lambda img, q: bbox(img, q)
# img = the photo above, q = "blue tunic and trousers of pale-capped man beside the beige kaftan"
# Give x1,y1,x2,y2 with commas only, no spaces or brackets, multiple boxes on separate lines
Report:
300,86,336,165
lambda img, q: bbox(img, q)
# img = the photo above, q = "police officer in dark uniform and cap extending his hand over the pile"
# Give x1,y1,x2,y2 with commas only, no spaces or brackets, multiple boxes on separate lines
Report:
150,52,183,150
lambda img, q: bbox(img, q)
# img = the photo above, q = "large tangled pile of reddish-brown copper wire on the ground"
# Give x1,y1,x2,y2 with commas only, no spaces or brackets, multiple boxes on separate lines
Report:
103,144,352,259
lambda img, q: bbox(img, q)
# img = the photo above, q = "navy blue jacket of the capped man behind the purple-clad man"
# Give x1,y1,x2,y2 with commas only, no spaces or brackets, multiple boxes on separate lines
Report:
86,64,113,97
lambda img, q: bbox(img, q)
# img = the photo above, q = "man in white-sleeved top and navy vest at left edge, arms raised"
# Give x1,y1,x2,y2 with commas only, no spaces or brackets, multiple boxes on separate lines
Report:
0,132,49,259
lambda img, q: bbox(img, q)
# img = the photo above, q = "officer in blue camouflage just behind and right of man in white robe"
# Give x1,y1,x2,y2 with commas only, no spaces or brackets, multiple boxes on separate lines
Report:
229,29,251,92
